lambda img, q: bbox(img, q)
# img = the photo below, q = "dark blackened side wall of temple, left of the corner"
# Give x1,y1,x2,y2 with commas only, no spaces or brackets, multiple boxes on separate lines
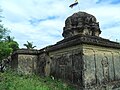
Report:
38,46,82,84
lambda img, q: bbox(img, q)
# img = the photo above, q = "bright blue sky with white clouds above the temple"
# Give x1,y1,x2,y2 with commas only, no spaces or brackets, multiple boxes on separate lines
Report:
0,0,120,49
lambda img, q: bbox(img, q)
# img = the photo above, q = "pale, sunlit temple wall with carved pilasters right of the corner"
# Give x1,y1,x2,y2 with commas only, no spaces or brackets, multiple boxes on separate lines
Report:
83,44,120,90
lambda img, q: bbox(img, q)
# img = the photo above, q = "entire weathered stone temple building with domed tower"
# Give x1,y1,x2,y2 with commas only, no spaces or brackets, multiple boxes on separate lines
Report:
11,12,120,90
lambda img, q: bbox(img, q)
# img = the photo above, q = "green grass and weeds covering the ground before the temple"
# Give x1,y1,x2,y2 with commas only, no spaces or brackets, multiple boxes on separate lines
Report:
0,72,75,90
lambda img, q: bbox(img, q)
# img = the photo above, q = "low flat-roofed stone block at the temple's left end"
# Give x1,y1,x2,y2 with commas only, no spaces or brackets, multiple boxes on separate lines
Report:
11,49,38,74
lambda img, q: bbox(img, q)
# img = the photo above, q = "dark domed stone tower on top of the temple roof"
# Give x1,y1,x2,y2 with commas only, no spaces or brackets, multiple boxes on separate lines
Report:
62,12,101,38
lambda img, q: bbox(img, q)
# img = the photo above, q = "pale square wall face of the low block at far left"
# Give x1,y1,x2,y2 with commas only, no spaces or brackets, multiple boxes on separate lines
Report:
18,54,37,74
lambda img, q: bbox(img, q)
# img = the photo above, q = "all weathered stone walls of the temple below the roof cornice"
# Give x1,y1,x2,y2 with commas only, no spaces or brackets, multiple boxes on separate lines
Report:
11,44,120,90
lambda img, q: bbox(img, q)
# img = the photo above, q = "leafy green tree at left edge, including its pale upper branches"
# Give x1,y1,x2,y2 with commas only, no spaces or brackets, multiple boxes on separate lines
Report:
0,8,19,71
